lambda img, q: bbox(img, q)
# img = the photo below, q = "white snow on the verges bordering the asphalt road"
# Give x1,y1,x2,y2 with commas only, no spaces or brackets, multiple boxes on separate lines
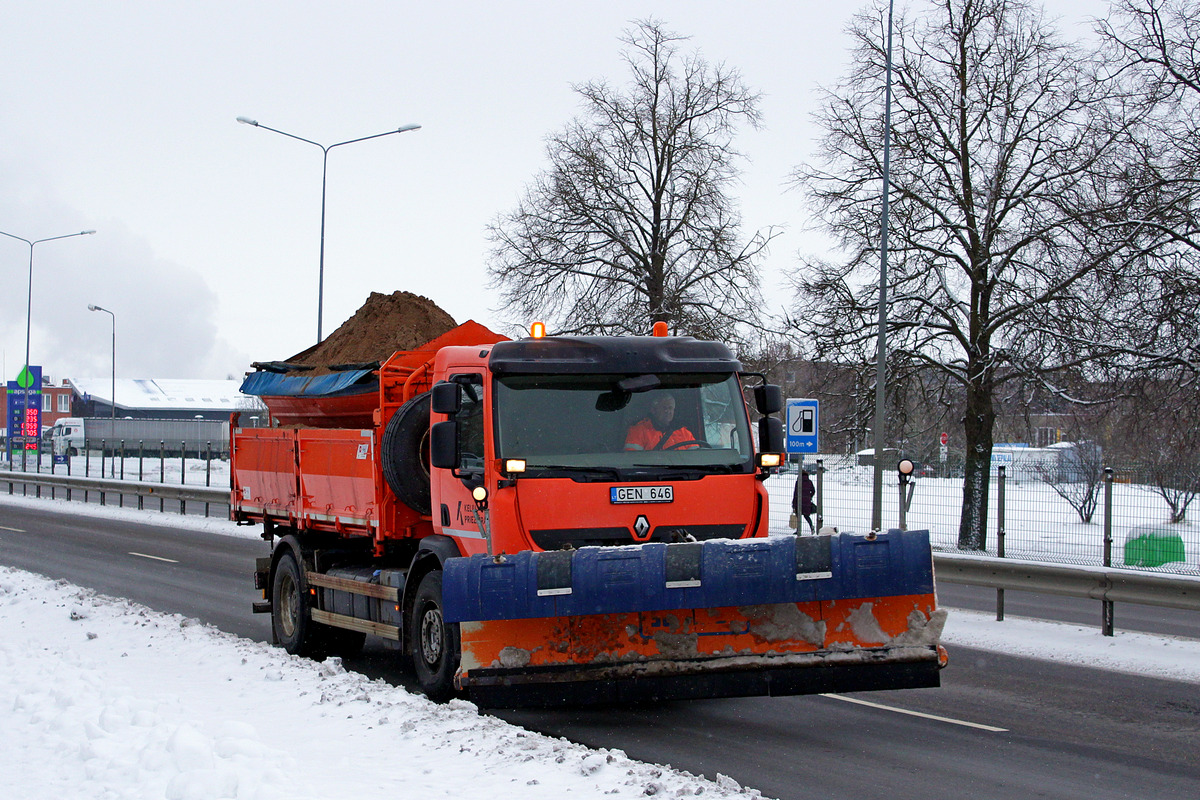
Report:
0,495,1200,800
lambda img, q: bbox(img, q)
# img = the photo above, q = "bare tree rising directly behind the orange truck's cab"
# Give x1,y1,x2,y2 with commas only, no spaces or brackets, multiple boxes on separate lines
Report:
488,20,774,341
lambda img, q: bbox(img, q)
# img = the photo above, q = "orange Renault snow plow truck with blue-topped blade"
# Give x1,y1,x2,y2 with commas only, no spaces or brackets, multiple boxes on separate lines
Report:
232,321,944,706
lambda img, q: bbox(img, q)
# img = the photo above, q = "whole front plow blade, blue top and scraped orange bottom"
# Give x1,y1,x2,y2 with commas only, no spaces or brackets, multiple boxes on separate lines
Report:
443,530,946,706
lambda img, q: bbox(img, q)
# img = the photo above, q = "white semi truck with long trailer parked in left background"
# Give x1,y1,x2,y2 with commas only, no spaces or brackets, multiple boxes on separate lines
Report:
50,416,229,456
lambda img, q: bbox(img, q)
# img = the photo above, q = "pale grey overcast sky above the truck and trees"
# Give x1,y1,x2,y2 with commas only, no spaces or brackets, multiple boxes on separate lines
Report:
0,0,1108,379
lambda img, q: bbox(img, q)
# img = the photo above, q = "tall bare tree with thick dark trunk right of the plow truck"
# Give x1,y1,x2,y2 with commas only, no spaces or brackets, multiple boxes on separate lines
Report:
794,0,1142,549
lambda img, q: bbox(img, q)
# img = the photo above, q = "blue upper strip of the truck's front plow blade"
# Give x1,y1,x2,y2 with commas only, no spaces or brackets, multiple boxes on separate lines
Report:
442,530,934,622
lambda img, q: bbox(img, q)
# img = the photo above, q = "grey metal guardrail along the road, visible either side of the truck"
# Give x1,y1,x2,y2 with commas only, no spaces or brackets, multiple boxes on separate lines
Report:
0,471,1200,636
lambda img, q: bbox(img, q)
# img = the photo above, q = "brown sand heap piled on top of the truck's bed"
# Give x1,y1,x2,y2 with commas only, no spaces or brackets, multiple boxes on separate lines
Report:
288,291,456,375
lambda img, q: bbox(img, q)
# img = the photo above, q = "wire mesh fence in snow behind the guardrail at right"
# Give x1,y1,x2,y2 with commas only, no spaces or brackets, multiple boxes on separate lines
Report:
767,457,1200,575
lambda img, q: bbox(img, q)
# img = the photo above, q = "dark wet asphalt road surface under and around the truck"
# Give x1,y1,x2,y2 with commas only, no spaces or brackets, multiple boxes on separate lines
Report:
0,499,1200,800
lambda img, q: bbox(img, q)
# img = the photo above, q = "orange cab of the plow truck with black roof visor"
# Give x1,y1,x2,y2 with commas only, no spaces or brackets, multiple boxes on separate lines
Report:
430,337,782,555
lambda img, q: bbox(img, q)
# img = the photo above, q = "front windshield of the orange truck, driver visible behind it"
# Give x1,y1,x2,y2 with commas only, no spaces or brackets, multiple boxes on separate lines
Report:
496,374,752,477
